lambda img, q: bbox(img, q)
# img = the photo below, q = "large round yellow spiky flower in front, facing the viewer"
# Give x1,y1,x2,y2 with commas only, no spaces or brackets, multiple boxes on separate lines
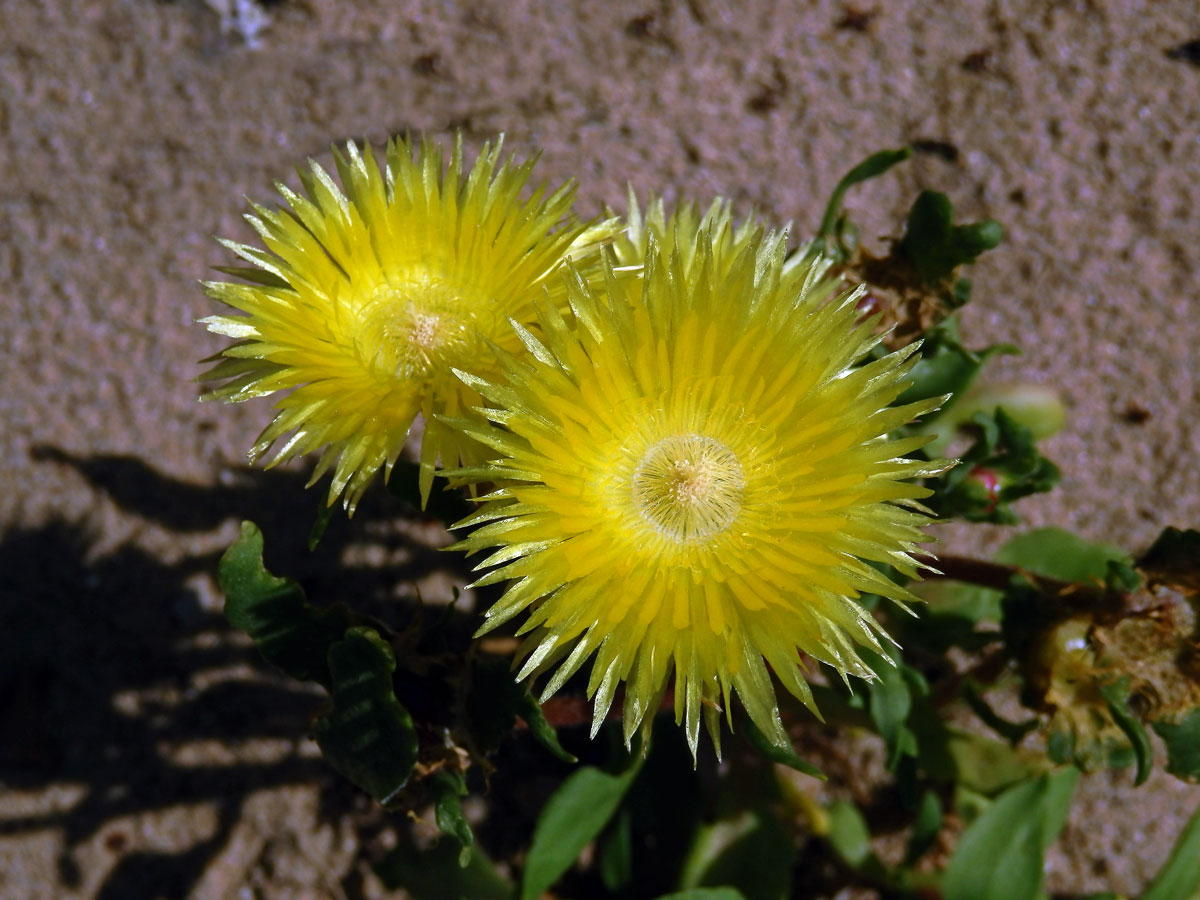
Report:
448,222,942,752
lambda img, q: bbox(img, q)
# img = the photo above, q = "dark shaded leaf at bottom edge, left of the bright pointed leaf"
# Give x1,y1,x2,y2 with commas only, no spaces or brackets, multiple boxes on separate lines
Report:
372,840,514,900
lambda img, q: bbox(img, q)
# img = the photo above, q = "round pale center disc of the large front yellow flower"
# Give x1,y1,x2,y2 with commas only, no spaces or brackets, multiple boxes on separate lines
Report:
634,434,745,542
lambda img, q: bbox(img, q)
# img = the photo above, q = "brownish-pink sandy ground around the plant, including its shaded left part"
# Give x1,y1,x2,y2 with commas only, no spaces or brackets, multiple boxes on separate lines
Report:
0,0,1200,900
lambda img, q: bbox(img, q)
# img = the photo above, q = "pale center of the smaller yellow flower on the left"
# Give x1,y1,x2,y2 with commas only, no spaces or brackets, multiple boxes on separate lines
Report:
356,274,481,379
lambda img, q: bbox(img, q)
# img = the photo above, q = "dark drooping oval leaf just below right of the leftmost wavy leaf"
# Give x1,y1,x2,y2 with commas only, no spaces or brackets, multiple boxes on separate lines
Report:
316,628,418,804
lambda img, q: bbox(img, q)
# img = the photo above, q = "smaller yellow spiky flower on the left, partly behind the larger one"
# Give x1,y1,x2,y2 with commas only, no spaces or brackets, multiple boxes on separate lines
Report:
203,137,611,512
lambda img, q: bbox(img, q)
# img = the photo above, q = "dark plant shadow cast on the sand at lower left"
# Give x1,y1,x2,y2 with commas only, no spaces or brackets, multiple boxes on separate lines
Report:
0,448,472,898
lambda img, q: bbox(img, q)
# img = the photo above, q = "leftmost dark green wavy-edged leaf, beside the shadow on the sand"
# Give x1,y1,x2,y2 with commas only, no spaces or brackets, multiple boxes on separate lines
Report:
217,522,353,688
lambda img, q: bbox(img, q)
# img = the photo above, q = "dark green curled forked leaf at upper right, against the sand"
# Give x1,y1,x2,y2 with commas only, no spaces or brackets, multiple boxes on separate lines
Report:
896,191,1004,284
